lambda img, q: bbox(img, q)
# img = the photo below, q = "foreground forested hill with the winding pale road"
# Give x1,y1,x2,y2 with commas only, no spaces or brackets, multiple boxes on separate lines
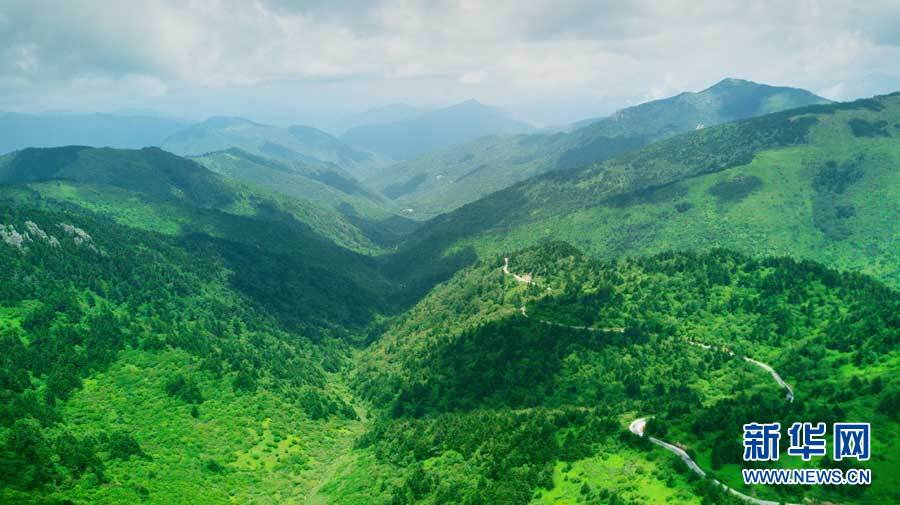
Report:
355,243,900,503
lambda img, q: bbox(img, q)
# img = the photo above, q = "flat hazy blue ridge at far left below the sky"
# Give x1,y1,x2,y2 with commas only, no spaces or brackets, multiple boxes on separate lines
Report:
0,112,186,154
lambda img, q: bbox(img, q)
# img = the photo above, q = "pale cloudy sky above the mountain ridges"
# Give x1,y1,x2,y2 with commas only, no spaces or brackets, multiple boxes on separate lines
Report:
0,0,900,126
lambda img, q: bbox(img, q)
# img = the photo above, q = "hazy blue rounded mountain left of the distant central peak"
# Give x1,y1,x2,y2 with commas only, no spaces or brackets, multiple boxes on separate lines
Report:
162,117,390,180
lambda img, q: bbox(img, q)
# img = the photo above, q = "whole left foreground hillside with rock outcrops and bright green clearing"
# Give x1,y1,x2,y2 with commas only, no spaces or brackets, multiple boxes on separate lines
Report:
0,205,378,503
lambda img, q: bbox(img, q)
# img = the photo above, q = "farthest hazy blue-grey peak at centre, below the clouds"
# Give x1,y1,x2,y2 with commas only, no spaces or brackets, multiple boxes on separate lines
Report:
340,100,531,160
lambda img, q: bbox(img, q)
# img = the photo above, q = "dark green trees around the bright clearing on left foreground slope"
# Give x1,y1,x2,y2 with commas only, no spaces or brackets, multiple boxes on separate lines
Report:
0,206,356,498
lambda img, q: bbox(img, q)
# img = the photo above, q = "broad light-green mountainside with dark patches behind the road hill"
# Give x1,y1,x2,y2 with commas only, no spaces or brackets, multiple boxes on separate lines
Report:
396,94,900,296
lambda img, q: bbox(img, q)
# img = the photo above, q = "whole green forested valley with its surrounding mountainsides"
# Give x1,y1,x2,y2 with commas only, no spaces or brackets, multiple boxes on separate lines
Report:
0,79,900,505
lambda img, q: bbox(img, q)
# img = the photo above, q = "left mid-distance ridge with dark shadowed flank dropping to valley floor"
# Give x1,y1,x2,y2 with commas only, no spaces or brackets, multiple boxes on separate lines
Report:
0,147,400,335
